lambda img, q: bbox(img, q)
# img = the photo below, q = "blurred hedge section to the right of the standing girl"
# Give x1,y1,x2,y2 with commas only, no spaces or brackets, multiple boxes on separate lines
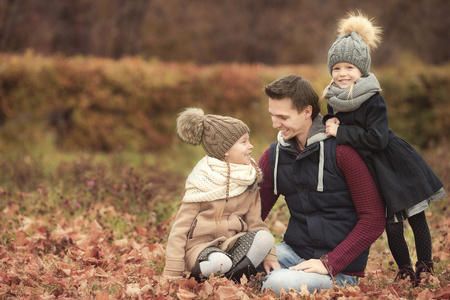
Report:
376,59,450,148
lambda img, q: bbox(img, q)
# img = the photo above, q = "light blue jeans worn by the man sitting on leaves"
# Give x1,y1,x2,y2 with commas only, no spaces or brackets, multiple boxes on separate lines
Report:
261,242,359,296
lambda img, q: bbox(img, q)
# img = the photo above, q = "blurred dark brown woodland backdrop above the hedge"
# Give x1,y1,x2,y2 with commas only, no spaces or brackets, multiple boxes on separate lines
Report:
0,0,450,66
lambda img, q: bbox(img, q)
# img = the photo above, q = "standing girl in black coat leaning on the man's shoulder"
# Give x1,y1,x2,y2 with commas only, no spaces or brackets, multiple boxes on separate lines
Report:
324,12,447,284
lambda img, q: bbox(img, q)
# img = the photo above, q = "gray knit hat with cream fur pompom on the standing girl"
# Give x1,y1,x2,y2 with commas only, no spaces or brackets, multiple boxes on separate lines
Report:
328,11,381,76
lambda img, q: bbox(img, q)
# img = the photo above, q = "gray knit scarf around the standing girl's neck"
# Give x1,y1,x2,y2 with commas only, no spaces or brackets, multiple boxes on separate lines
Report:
325,73,381,114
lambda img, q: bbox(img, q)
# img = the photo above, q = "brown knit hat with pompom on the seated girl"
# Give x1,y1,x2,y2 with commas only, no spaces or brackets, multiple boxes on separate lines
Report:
177,107,250,159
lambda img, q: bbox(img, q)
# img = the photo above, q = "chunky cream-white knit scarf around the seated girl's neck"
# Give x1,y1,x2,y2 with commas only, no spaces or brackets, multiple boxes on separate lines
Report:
182,156,256,202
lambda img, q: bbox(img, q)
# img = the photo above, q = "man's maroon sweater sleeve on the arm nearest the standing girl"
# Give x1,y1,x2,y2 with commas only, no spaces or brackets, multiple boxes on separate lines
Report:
321,145,386,276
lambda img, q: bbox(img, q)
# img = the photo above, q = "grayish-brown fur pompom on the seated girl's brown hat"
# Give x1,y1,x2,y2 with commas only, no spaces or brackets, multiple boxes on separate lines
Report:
177,107,205,145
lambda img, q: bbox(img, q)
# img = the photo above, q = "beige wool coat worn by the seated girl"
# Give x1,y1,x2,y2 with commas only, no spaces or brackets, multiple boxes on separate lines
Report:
163,190,277,276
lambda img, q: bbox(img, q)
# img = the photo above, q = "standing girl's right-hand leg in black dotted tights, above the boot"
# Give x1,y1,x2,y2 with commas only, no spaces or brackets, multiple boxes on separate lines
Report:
408,212,432,262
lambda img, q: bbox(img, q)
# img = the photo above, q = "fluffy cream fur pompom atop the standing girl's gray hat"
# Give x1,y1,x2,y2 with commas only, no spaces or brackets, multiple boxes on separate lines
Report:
338,11,382,51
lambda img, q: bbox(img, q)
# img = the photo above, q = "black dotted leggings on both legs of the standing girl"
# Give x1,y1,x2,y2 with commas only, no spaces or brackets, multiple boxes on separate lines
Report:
386,212,432,267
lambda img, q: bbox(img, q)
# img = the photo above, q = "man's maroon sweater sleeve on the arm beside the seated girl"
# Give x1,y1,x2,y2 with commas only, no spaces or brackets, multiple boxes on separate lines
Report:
258,148,279,220
